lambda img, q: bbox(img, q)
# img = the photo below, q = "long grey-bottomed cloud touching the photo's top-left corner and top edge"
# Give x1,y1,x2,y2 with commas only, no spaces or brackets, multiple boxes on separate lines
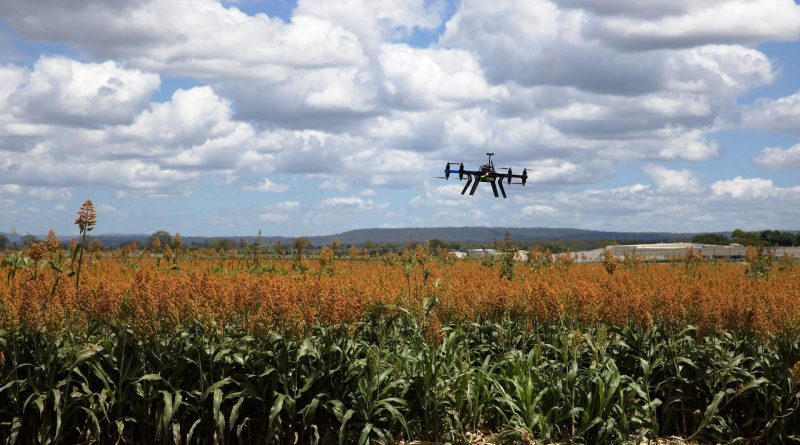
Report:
0,0,364,80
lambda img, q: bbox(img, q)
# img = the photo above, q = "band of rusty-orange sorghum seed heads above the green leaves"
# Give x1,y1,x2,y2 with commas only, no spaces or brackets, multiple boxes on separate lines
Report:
0,259,800,335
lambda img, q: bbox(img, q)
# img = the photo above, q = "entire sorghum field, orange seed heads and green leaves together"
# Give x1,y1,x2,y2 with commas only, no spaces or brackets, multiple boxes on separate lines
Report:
0,206,800,444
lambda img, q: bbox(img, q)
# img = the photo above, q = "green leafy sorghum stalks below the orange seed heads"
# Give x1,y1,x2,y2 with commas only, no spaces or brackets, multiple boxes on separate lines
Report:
0,308,800,444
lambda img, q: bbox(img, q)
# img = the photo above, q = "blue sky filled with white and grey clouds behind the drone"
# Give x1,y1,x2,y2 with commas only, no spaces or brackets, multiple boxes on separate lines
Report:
0,0,800,236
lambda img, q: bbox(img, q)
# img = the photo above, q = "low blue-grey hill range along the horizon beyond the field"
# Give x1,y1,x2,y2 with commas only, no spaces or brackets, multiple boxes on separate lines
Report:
3,227,695,247
